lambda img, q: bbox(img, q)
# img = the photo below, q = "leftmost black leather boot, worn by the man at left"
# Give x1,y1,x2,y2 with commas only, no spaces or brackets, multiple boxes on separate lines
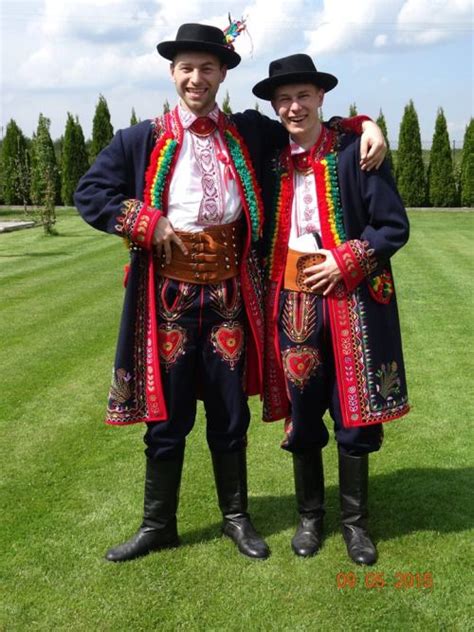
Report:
105,453,184,562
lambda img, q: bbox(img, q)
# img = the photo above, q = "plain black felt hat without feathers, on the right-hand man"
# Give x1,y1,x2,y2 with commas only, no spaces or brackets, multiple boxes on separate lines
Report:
252,54,337,101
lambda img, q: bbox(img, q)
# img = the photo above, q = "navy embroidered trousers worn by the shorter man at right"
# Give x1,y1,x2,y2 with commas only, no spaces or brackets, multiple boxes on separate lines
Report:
278,290,383,455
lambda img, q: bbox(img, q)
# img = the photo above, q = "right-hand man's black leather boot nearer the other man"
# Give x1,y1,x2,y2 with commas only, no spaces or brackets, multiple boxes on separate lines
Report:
291,450,324,557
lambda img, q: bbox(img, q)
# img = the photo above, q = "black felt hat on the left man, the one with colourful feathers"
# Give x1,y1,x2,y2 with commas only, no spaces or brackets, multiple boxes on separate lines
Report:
156,23,240,68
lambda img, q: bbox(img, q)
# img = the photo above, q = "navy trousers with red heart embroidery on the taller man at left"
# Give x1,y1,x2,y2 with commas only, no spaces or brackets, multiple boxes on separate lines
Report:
144,277,250,459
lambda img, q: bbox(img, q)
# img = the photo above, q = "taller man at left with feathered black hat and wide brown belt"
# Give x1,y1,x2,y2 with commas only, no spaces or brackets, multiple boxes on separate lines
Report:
75,24,386,562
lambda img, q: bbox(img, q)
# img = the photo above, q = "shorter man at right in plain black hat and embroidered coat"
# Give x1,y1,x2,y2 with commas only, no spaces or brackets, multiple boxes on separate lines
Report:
253,54,409,564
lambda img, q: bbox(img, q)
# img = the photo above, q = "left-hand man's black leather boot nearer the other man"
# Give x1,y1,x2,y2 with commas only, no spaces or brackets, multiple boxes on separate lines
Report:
212,450,270,559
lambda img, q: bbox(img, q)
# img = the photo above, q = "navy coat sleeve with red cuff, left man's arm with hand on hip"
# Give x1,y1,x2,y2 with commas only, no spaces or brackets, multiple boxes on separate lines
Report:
74,124,161,248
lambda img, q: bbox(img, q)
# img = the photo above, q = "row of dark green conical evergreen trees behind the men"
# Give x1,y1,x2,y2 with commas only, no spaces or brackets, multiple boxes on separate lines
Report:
0,94,474,208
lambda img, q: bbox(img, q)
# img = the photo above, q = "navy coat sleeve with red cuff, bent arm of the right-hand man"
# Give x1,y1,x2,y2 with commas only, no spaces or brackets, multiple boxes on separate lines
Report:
333,139,409,290
